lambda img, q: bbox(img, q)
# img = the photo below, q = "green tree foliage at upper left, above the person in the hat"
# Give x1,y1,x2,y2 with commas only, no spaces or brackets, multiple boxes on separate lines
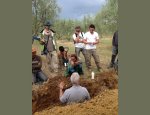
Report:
32,0,60,35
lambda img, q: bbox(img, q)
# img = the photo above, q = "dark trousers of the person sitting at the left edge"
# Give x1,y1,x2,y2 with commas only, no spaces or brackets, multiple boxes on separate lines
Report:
32,71,48,83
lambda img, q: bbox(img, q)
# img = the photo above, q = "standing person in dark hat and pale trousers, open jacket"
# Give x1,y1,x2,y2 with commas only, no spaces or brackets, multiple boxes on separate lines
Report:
41,22,58,72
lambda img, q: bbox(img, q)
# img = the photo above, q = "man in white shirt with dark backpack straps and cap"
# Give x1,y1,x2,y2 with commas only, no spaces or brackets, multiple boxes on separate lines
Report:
72,26,86,62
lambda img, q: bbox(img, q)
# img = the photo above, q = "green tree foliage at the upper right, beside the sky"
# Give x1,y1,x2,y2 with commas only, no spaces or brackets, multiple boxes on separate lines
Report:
95,0,118,34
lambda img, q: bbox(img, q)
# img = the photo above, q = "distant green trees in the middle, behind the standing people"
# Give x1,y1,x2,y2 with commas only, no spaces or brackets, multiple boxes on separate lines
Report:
54,16,94,41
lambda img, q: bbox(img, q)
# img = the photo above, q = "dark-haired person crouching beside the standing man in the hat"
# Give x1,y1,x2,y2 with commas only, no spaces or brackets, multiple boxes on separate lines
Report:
58,46,68,67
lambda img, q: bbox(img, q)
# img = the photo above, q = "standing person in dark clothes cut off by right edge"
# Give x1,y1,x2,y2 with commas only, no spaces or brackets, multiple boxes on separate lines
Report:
108,30,118,68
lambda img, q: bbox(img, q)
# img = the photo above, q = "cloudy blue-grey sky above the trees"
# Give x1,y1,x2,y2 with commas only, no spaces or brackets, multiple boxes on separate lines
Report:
57,0,106,19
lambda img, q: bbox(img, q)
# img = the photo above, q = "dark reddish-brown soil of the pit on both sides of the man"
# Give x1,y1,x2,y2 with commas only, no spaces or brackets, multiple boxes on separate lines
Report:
32,71,118,113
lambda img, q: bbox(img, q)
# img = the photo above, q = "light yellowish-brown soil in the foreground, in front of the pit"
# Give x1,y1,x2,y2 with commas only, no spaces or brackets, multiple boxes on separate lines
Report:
35,89,118,115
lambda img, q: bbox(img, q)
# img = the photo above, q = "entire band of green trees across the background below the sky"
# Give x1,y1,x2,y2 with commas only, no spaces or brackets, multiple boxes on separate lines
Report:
32,0,118,40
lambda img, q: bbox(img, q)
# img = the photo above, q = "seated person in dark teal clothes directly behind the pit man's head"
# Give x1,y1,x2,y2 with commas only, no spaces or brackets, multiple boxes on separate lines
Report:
65,54,83,77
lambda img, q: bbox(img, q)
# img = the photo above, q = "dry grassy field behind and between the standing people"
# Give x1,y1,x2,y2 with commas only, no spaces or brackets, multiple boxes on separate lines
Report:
32,37,112,76
